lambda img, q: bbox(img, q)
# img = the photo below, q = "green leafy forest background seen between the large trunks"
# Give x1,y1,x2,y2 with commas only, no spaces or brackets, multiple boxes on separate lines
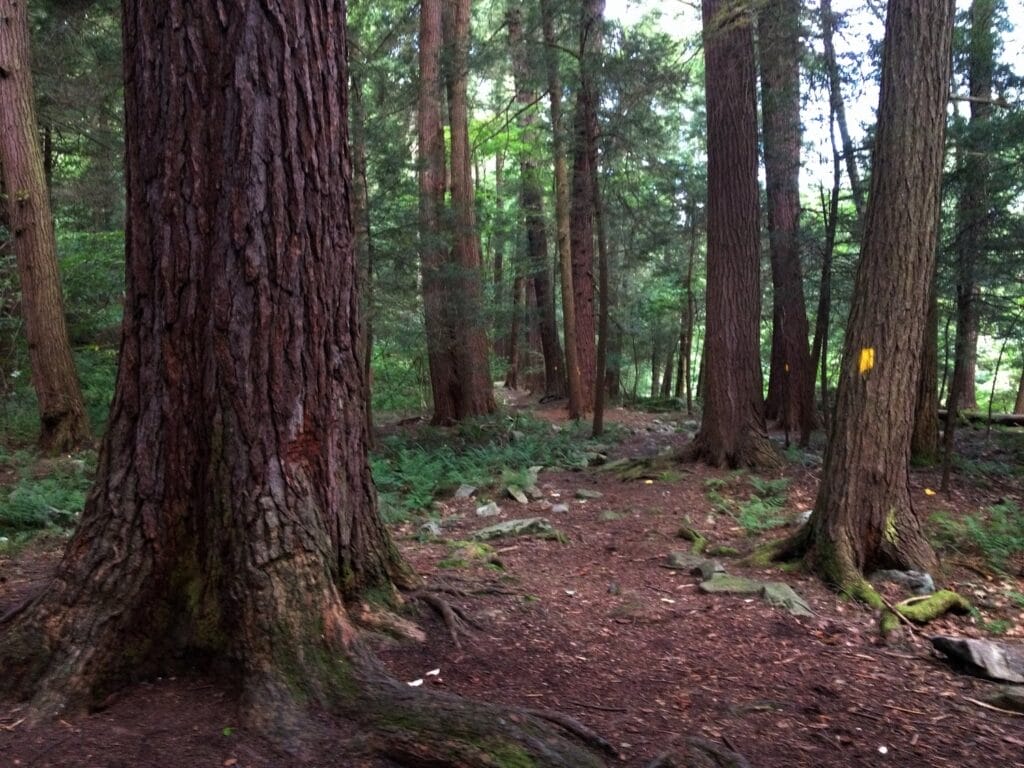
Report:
0,0,1024,483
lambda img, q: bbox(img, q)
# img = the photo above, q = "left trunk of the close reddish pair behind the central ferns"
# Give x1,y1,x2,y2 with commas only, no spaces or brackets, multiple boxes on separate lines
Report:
416,0,459,424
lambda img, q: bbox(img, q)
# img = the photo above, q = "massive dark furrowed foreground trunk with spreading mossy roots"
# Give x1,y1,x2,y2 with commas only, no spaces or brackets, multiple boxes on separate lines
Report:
0,0,600,767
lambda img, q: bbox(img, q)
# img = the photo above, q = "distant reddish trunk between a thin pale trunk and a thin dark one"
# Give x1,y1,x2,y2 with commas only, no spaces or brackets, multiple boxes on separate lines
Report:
569,0,604,412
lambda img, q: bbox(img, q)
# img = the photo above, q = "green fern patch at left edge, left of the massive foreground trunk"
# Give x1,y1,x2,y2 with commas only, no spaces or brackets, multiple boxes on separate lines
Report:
0,452,93,536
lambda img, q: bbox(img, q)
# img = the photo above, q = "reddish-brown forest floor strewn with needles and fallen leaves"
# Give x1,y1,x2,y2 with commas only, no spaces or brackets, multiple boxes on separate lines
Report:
0,393,1024,768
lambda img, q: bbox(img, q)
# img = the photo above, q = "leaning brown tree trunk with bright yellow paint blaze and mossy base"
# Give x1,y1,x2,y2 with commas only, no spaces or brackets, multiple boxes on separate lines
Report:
777,0,953,589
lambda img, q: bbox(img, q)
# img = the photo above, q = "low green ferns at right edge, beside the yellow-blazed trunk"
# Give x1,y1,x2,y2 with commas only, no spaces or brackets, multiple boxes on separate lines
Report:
931,502,1024,571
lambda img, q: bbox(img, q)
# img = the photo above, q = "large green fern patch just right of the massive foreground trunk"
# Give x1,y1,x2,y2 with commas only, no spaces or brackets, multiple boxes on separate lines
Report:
371,416,614,522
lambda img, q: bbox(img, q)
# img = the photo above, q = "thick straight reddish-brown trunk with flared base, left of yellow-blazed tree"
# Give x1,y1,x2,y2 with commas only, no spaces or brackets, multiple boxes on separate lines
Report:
691,0,779,468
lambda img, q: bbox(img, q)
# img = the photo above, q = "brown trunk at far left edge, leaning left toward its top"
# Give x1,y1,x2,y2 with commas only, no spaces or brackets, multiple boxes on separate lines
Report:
0,0,89,454
